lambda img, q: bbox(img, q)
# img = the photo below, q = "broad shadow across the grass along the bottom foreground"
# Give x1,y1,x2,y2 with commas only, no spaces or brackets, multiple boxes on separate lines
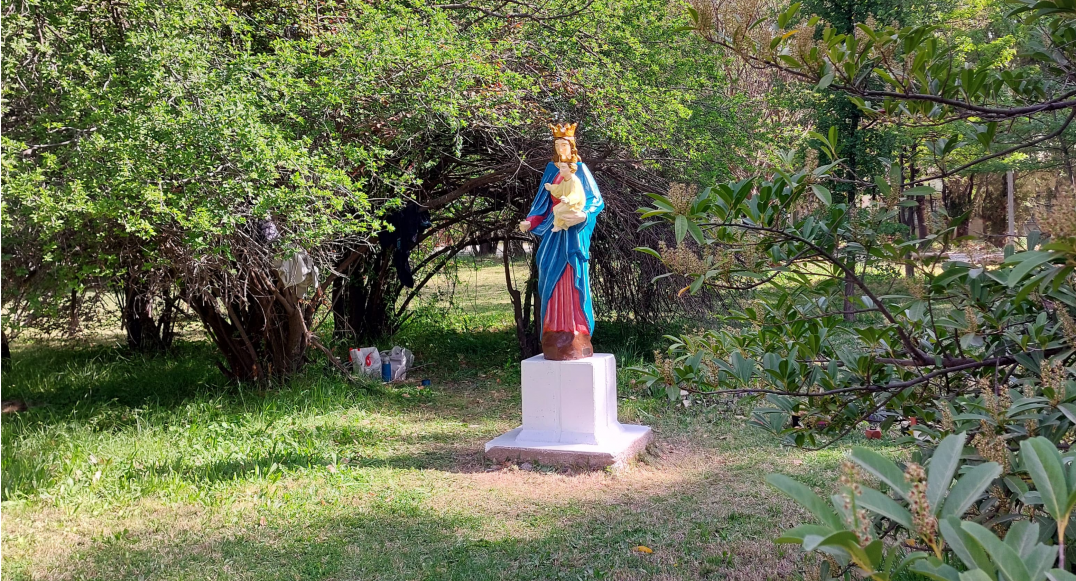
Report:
4,466,801,581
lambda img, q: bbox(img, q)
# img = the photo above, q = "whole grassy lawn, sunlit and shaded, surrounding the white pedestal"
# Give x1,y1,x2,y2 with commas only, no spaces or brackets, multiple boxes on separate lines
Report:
0,267,912,580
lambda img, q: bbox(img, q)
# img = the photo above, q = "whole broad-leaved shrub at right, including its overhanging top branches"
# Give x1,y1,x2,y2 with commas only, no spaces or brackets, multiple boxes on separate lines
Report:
639,1,1076,559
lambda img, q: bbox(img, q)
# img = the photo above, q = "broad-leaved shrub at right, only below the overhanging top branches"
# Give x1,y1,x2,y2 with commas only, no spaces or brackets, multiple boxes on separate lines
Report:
628,125,1076,568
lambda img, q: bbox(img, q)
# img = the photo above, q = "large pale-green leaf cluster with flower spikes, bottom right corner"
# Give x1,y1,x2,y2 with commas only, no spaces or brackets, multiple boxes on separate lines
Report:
767,434,1076,581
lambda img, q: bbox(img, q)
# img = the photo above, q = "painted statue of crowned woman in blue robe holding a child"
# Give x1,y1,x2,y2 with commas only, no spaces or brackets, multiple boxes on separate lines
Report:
520,124,605,360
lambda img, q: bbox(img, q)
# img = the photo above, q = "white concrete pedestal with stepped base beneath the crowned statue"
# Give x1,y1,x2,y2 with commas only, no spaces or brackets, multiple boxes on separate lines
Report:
485,353,651,468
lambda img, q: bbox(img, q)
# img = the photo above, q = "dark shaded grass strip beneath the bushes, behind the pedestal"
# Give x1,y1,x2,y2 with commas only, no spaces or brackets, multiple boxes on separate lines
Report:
3,320,675,415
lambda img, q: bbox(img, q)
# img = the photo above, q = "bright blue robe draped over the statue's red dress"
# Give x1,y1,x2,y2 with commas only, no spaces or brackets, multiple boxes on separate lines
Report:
527,161,605,335
